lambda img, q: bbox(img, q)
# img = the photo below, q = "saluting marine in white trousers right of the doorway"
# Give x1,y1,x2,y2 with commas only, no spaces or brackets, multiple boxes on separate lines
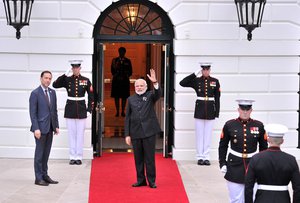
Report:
179,63,221,166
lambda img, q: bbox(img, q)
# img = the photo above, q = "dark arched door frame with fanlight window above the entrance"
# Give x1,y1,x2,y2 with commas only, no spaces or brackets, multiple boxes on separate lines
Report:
92,0,175,157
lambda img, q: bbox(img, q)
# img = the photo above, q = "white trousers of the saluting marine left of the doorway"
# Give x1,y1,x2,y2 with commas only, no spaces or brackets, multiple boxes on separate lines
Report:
66,118,86,160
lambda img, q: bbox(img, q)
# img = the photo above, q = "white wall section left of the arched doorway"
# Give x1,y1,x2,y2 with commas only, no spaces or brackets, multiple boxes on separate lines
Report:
0,0,97,159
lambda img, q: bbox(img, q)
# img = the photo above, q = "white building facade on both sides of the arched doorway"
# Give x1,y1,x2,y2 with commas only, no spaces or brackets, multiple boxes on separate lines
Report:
0,0,300,160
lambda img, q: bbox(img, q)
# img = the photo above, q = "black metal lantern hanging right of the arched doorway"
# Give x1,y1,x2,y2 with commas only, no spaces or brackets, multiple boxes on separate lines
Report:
235,0,266,41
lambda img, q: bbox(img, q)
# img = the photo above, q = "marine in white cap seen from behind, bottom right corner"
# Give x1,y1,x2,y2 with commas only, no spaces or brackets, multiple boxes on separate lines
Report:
245,124,300,203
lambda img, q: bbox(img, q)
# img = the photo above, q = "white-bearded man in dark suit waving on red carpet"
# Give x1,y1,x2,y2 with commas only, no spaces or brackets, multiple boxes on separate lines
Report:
125,69,161,188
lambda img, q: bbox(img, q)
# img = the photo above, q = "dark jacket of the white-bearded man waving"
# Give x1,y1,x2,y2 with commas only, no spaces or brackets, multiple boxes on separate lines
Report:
125,87,161,139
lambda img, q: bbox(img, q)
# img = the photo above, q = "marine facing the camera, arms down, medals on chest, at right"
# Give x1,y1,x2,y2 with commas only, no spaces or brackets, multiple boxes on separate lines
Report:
219,99,268,203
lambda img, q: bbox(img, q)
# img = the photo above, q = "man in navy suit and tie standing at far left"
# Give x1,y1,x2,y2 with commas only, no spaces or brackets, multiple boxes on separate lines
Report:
29,71,59,186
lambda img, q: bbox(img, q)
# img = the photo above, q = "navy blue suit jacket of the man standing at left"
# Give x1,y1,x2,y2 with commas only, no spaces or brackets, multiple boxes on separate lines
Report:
29,86,59,134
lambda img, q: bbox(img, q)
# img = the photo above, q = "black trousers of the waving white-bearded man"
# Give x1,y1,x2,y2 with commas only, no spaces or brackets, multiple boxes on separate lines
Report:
132,135,156,184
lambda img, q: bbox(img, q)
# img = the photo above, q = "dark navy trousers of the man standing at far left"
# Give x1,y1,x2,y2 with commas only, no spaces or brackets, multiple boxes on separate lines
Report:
34,131,53,180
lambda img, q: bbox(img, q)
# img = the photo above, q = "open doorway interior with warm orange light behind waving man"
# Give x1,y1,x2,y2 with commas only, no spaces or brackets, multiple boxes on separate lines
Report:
99,43,165,152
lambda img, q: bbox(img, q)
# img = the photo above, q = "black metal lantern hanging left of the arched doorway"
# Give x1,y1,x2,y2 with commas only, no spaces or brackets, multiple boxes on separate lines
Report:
3,0,34,39
